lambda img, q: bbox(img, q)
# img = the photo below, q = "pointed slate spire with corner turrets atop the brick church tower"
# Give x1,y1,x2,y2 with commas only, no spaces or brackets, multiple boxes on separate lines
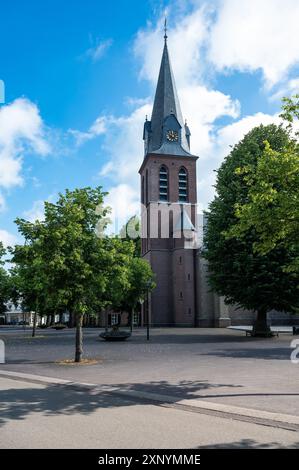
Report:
145,25,190,155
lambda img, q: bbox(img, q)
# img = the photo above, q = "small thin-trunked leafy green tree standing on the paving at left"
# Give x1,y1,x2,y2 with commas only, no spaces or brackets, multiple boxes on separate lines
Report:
12,187,113,362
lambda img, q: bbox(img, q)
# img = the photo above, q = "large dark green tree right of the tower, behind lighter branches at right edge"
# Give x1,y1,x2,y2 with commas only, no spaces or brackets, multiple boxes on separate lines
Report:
204,124,299,335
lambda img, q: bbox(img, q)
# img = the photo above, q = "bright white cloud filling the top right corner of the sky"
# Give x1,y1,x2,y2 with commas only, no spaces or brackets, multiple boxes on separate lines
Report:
209,0,299,87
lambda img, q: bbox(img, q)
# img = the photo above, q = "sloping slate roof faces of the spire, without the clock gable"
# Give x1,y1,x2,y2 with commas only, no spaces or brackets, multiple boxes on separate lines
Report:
148,37,190,155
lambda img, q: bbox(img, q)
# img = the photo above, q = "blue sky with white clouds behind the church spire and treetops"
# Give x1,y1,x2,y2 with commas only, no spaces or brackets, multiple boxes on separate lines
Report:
0,0,299,243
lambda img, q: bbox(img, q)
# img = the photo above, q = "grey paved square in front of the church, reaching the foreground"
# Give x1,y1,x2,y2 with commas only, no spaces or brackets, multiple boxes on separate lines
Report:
0,328,299,447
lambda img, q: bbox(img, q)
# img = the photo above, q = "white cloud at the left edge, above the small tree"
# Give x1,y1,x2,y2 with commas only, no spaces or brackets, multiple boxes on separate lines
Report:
0,98,50,188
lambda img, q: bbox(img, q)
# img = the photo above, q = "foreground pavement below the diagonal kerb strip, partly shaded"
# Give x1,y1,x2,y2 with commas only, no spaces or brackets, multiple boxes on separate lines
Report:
0,372,299,449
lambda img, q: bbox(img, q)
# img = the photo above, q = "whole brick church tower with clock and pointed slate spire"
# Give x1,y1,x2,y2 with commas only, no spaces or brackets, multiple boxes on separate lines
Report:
139,28,198,326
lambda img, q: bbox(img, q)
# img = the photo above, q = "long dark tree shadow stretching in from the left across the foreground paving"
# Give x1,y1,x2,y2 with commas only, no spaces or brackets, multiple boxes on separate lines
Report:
0,380,240,426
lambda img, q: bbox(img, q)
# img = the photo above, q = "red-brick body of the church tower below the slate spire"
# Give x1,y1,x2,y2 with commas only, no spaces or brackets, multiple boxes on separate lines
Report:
140,154,197,326
